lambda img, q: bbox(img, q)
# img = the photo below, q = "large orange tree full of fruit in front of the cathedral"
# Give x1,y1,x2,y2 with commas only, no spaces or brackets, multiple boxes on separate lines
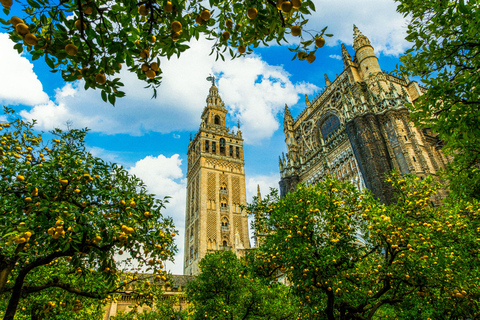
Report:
249,174,480,320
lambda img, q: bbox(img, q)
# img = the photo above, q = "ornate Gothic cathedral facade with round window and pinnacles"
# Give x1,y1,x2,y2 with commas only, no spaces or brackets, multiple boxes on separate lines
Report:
279,26,447,203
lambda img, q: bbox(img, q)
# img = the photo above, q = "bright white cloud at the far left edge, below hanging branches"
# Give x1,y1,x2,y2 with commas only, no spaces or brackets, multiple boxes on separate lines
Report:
0,33,48,106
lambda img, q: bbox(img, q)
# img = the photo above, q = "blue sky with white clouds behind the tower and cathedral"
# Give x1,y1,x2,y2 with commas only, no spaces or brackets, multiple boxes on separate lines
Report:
0,0,408,274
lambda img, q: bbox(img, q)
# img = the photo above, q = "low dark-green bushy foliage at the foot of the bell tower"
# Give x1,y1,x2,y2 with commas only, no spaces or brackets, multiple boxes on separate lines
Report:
187,251,298,320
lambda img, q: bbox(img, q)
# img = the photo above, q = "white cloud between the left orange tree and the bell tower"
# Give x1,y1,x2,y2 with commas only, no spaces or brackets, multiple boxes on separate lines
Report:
129,154,186,274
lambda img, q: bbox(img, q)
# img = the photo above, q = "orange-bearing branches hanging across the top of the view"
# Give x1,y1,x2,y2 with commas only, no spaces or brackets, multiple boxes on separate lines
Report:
0,0,331,104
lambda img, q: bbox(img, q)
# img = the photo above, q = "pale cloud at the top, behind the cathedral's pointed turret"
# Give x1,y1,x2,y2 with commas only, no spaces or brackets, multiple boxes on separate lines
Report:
314,0,410,55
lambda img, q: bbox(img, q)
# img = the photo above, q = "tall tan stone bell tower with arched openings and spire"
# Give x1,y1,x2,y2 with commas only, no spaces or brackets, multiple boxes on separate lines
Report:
183,79,250,275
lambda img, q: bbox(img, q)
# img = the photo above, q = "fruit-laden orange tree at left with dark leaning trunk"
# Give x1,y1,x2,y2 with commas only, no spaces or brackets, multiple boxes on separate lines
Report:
0,109,176,319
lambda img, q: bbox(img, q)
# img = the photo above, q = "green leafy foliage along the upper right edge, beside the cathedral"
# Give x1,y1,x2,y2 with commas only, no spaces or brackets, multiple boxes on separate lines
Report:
397,0,480,199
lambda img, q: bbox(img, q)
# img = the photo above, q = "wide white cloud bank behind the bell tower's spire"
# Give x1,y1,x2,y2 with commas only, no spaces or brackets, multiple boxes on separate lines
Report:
21,35,318,143
